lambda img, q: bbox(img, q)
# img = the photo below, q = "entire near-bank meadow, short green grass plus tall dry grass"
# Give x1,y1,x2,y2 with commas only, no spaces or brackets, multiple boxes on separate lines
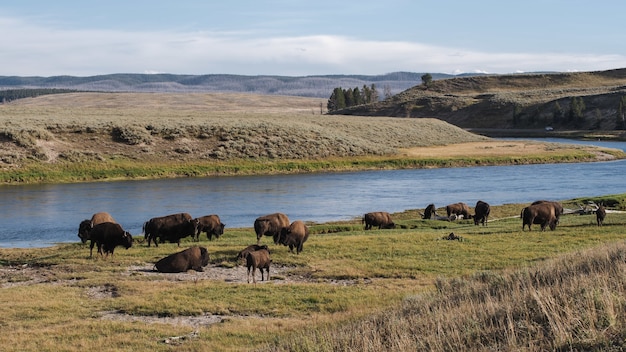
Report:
0,194,626,351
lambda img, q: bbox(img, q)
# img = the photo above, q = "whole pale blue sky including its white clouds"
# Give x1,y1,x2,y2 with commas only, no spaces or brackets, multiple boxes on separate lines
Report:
0,0,626,77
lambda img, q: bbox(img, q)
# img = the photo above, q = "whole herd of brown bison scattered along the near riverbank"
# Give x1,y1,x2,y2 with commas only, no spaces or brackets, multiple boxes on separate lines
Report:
78,200,606,283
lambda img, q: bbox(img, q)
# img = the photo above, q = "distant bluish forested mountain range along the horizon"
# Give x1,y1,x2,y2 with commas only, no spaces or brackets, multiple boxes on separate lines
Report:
0,72,475,98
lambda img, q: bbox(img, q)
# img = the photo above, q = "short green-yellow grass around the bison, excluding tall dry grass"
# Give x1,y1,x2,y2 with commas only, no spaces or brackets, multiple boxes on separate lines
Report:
0,195,626,351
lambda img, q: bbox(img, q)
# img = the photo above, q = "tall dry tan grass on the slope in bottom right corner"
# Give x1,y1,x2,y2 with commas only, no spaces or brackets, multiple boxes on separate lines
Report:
266,242,626,351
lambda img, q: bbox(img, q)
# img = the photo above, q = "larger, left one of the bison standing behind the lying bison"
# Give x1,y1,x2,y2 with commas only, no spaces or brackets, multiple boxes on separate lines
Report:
143,213,197,247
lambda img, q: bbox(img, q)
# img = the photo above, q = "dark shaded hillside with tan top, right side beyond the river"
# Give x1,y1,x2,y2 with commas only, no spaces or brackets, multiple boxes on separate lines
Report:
336,69,626,131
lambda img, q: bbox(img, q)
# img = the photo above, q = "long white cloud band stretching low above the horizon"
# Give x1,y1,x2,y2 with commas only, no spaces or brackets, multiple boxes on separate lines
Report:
0,18,626,76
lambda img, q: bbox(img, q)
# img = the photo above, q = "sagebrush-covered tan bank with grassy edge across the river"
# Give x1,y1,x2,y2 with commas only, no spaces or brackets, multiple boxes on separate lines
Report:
0,93,626,184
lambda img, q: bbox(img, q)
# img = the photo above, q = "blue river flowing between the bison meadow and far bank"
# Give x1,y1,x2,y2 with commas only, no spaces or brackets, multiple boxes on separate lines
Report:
0,139,626,247
